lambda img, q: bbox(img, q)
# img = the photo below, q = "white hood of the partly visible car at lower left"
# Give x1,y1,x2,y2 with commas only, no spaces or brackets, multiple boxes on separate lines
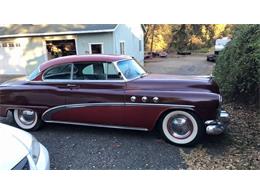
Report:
0,123,32,170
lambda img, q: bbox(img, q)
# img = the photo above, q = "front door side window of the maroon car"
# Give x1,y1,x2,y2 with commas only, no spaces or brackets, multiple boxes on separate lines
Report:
73,62,121,80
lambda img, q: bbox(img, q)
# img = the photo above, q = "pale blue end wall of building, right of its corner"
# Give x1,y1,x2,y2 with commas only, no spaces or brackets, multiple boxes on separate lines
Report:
114,24,144,64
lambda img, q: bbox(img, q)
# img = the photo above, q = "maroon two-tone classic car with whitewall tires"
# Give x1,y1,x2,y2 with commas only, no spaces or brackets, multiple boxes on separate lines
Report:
0,55,229,145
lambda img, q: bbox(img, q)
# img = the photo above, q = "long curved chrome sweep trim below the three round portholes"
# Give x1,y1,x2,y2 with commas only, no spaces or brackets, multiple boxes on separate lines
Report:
42,102,194,121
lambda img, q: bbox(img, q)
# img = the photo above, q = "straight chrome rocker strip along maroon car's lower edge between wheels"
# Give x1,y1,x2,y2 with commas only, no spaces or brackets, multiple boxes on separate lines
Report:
45,120,148,131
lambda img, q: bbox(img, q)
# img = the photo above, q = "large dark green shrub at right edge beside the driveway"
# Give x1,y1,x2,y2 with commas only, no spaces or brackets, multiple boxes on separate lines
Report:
213,25,260,105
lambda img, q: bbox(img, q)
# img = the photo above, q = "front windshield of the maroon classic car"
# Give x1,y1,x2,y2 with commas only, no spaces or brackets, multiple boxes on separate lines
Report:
117,60,147,80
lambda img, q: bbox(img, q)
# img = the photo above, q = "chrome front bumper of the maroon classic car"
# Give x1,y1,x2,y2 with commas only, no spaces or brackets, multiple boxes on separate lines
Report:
205,110,229,135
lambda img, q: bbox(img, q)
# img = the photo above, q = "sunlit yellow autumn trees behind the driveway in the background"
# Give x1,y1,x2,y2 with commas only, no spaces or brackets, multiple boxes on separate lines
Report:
144,24,233,51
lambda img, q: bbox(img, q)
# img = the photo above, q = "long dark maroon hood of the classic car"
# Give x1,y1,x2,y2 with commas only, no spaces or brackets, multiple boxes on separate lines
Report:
129,74,219,93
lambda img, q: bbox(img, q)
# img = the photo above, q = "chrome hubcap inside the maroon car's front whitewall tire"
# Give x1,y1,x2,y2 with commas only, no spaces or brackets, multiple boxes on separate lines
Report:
167,115,193,139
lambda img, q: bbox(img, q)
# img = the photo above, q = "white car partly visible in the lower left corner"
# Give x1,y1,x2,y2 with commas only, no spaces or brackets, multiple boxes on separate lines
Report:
0,123,50,170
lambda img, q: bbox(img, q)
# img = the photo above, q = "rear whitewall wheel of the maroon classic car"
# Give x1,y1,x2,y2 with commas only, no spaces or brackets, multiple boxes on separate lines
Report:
13,109,41,131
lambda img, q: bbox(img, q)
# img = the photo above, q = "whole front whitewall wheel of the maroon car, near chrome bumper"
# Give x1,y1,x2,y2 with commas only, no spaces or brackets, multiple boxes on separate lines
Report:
161,110,204,146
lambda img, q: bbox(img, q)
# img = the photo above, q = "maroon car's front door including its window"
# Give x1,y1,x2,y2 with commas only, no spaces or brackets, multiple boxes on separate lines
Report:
63,62,125,126
